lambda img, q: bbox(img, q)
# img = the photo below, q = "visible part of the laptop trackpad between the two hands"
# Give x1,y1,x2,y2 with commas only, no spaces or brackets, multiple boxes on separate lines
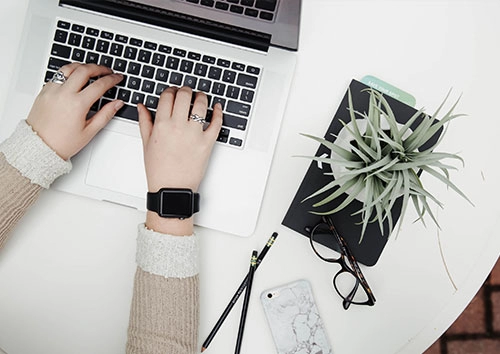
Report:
85,130,147,198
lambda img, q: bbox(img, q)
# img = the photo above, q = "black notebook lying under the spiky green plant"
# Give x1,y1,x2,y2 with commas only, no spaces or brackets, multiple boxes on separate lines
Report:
282,80,439,266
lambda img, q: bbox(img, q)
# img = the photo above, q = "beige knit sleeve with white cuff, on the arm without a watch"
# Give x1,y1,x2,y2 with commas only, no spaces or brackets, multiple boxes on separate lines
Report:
0,122,71,248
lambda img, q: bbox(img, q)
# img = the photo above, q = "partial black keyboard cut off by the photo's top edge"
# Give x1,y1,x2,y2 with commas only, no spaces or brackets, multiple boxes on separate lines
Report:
178,0,278,22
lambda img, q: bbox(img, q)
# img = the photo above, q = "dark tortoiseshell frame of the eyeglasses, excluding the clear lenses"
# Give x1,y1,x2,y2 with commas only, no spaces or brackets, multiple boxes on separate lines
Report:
306,215,376,310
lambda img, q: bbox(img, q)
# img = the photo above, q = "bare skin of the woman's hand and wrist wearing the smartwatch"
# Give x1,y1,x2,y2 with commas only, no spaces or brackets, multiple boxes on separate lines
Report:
137,87,222,235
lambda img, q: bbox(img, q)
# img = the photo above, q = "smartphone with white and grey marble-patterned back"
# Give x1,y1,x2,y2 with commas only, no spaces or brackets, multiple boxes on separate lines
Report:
260,280,332,354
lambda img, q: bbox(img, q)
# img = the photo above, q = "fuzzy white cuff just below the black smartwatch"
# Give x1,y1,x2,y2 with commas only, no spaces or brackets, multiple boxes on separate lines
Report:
136,224,198,278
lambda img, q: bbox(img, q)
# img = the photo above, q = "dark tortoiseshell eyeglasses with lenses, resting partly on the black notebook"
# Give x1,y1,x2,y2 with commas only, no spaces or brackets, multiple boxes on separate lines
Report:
306,216,375,310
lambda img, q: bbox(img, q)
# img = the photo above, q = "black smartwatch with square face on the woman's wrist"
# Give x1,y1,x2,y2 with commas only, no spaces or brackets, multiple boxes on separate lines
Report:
146,188,200,219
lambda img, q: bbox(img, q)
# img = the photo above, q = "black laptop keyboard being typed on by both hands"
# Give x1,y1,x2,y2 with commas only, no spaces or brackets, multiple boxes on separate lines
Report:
45,20,261,148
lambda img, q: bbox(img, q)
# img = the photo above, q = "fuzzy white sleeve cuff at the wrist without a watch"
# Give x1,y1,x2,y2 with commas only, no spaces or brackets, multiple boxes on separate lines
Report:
0,120,72,188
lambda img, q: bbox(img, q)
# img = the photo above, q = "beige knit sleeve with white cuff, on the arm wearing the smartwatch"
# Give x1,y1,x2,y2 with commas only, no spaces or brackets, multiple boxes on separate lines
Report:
127,225,199,354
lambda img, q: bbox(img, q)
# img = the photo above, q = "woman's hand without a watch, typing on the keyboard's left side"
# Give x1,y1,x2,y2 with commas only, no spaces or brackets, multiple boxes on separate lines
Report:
27,63,123,160
